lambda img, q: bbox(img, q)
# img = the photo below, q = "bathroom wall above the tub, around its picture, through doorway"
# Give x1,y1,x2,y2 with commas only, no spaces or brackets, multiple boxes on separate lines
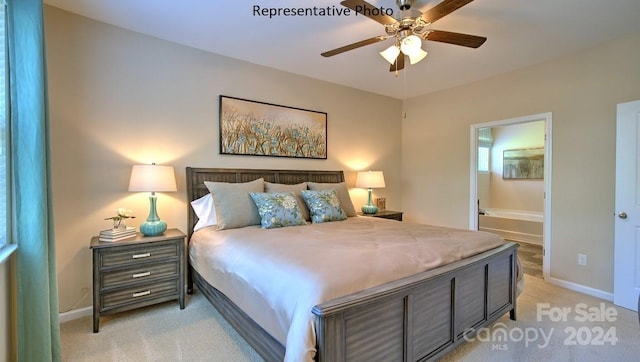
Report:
487,121,544,212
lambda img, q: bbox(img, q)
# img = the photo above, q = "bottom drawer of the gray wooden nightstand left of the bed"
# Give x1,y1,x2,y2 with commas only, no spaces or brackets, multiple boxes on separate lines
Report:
100,278,180,312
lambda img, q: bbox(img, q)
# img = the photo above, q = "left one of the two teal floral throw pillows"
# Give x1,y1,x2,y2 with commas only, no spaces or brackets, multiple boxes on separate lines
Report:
249,192,307,229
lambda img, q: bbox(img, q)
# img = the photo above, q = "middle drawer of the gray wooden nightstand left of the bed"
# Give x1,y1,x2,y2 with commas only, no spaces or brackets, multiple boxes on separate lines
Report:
100,260,180,289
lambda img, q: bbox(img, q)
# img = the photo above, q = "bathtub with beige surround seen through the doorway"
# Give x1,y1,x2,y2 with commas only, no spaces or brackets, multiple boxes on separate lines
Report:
478,208,544,244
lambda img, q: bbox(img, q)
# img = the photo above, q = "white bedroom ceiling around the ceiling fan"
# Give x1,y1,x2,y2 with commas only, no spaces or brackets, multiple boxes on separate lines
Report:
45,0,640,99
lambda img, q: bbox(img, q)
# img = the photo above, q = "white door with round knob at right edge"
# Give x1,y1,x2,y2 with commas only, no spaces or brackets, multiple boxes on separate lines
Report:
613,101,640,310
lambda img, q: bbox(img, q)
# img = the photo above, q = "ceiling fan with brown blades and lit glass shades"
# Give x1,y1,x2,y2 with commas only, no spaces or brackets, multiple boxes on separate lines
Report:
321,0,487,72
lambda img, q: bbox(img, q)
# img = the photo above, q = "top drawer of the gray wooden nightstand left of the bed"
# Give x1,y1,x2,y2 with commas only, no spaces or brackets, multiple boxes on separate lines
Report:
99,243,180,269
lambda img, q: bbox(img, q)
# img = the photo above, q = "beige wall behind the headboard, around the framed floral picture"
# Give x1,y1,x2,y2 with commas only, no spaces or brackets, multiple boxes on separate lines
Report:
45,7,402,312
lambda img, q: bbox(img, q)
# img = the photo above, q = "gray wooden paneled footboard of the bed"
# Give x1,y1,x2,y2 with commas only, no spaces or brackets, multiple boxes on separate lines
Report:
313,243,518,361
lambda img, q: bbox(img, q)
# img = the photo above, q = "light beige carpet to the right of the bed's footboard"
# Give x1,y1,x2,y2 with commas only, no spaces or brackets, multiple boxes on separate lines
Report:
442,274,640,362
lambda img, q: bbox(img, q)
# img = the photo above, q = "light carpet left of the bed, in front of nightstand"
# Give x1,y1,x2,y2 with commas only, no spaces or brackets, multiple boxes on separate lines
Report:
60,291,262,362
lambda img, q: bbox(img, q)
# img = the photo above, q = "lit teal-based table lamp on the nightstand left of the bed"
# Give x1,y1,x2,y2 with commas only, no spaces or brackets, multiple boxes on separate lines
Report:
129,163,177,236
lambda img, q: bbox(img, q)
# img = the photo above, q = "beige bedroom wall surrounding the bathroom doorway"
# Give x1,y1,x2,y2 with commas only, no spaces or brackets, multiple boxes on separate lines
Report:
402,30,640,293
